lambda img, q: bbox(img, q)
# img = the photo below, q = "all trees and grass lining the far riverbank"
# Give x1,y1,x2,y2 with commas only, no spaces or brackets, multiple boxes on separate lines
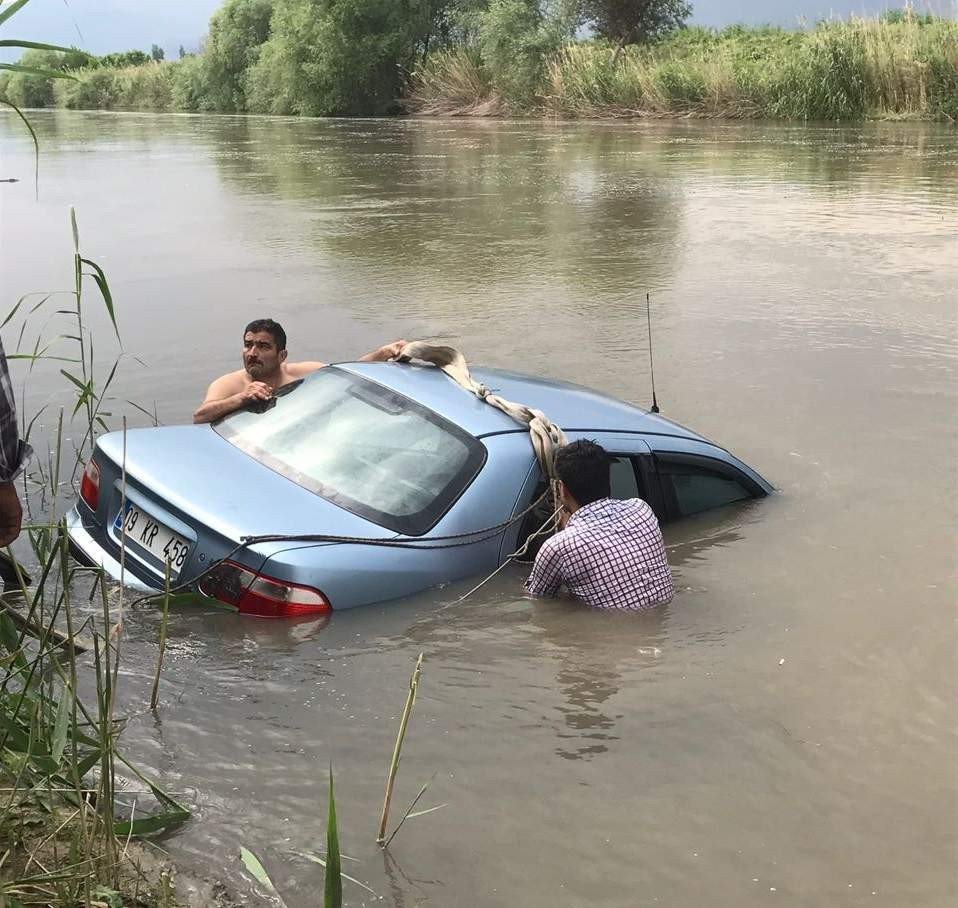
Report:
0,0,958,121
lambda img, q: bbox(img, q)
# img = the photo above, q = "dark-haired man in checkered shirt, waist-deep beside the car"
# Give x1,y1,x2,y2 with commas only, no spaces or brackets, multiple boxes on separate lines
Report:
526,441,674,611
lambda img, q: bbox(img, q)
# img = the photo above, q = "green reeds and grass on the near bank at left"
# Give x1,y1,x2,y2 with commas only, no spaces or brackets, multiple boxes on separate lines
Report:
0,213,189,906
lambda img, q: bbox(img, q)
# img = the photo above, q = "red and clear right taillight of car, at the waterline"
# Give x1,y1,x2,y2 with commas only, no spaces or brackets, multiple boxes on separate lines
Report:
199,561,333,618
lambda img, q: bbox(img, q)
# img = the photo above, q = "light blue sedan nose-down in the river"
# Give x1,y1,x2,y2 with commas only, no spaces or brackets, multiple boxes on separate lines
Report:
68,363,772,617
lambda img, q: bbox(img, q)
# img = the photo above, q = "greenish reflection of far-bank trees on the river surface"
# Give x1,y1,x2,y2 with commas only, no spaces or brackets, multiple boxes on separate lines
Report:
206,120,681,292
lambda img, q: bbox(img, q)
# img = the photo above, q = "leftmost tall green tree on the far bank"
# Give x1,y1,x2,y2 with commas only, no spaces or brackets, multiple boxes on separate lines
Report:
203,0,273,113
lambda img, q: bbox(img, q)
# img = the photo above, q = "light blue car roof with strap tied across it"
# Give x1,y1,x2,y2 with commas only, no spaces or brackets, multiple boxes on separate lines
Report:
336,363,707,441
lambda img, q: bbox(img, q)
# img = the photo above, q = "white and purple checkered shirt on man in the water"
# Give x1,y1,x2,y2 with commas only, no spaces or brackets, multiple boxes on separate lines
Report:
526,498,674,610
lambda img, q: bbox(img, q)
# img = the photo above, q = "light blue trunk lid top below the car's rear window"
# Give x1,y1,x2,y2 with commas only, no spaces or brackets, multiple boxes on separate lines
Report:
98,425,395,540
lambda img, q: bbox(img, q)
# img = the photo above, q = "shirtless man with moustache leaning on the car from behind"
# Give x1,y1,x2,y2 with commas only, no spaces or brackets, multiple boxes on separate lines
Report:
193,318,406,422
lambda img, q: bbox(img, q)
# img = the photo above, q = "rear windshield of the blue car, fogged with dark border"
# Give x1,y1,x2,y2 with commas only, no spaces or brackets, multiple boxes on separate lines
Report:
214,366,486,536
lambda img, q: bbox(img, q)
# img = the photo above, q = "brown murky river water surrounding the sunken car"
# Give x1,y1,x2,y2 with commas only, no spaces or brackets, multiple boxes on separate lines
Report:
0,112,958,908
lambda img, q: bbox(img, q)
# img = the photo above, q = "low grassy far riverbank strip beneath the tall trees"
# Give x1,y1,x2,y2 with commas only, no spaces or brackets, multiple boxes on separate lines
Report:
0,17,958,122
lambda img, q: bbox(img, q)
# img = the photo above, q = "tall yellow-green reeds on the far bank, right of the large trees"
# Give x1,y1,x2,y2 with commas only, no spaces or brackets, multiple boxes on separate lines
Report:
408,17,958,120
